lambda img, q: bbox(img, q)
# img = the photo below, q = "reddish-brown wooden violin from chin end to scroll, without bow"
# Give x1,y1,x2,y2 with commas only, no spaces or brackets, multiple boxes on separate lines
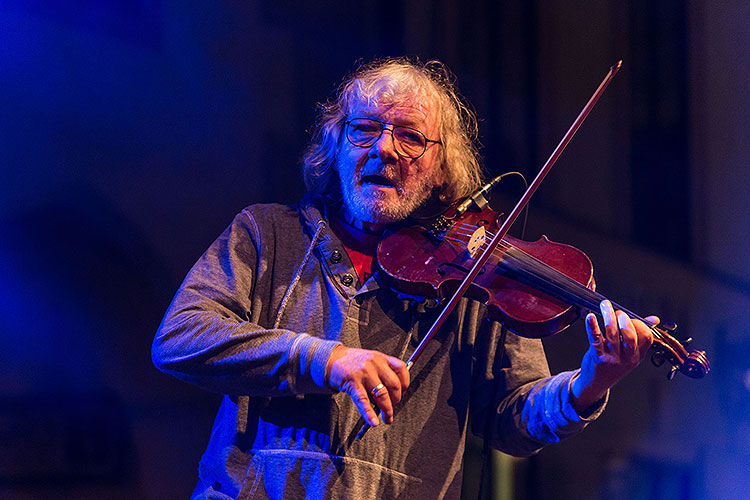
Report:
377,202,710,379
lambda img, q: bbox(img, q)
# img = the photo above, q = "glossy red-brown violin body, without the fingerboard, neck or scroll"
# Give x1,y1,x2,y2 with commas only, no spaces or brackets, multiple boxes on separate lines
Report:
377,209,594,338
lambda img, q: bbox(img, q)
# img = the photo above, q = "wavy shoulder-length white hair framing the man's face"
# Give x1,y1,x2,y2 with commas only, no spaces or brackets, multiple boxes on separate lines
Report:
302,58,484,203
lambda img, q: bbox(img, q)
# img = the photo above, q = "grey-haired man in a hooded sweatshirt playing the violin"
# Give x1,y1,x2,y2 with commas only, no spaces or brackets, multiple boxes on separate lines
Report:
153,59,657,499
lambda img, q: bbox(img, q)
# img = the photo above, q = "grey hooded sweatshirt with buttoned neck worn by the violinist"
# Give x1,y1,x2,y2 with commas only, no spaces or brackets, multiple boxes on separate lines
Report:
152,198,605,500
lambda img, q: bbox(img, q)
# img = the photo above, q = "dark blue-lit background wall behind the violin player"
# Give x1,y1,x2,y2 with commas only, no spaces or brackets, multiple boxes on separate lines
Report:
0,0,750,499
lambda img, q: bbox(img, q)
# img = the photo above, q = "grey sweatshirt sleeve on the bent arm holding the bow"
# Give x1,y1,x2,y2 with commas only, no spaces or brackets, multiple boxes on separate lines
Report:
151,211,338,396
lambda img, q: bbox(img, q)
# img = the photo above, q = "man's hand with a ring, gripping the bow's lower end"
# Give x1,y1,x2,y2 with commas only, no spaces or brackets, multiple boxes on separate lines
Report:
326,345,409,427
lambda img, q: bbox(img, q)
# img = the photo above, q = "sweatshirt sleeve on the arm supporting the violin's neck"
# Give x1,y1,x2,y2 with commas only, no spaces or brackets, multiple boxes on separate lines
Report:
472,324,609,457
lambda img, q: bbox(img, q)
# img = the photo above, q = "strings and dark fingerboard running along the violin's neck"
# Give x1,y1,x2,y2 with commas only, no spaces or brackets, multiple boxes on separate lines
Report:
446,223,666,343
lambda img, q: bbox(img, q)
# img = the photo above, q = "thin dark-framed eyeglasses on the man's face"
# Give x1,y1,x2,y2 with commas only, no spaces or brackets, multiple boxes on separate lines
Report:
345,118,443,159
